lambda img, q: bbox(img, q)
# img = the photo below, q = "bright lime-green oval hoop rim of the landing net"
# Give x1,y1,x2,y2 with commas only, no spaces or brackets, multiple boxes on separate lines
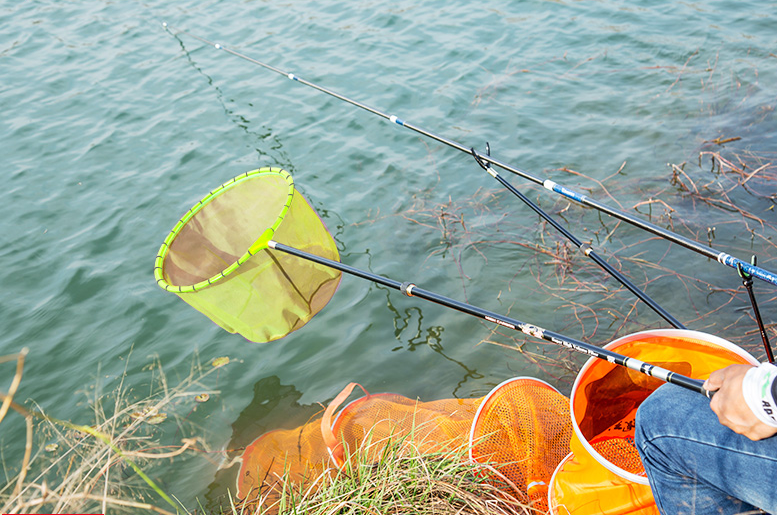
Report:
154,166,295,293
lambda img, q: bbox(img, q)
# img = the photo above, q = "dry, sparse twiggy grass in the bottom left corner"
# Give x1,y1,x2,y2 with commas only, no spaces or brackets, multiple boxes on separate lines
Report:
0,350,218,514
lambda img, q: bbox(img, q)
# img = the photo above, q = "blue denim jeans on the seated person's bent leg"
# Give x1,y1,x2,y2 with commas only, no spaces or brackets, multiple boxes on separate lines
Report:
635,384,777,515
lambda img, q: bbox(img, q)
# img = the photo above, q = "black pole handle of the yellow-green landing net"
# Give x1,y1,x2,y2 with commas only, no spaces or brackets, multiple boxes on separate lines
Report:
267,240,715,398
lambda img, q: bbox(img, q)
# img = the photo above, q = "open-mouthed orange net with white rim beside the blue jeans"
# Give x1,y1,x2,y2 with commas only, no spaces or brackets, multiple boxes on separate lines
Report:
549,329,757,515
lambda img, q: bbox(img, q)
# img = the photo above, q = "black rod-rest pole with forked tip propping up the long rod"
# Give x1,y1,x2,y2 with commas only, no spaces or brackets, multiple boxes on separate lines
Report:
471,143,685,329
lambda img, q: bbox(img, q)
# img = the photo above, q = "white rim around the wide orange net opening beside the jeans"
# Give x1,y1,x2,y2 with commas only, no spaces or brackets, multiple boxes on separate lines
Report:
569,329,758,485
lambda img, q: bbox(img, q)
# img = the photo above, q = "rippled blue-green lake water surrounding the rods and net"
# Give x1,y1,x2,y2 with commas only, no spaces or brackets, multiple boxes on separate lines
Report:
0,0,777,505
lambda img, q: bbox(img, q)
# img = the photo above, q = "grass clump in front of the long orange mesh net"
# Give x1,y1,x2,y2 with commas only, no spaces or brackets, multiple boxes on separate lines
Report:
231,439,540,515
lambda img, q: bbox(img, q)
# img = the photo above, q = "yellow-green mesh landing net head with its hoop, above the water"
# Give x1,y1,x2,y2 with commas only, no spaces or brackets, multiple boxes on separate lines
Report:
154,168,341,342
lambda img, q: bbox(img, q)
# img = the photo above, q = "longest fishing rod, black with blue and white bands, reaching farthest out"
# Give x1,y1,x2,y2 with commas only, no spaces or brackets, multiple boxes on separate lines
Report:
162,22,777,285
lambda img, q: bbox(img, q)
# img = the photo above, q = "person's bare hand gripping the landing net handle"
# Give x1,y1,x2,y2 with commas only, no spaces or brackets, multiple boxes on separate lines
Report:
704,365,777,440
